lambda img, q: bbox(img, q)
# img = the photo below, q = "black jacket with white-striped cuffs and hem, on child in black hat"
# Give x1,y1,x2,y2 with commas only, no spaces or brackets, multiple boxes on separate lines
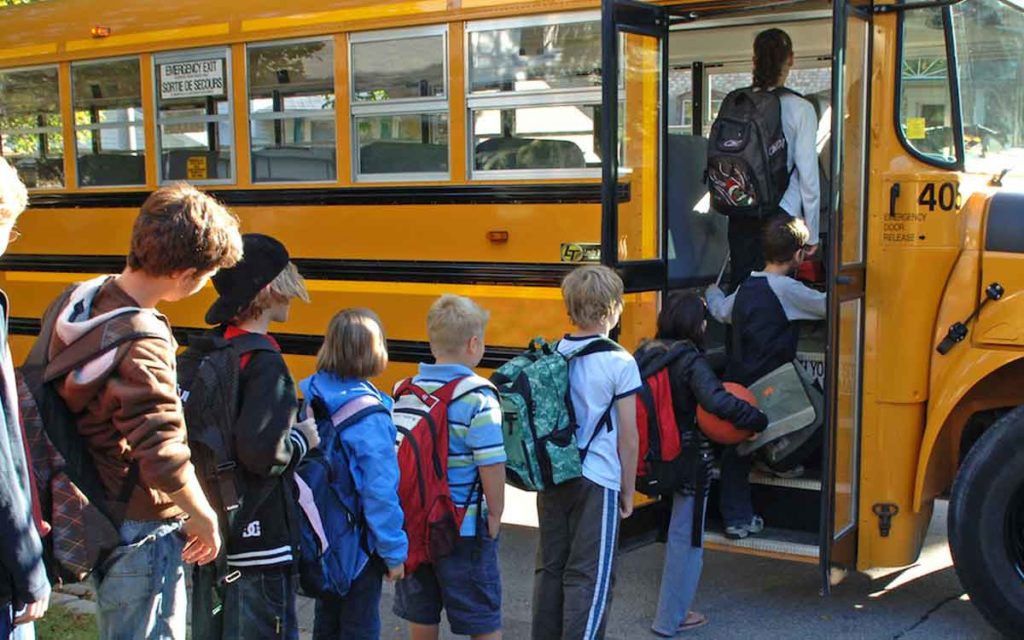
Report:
218,329,307,569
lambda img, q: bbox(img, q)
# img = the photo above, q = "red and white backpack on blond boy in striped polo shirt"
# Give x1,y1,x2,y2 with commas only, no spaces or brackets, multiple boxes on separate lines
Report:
391,376,494,575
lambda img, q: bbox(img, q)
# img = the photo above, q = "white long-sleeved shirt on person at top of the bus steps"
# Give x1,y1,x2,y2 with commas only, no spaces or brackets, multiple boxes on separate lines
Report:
778,92,821,239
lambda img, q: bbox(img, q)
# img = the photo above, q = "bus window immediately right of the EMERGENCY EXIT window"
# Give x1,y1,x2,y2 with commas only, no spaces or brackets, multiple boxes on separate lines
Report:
246,39,338,182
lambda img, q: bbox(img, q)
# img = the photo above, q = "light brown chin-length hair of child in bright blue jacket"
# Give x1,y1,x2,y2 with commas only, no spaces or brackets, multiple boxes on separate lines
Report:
316,309,388,378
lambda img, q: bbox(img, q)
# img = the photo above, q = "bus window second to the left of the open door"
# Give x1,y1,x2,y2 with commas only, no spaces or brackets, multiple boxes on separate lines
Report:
349,26,449,181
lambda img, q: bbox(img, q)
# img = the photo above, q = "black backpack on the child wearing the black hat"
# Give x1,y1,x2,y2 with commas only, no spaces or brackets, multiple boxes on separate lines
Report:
178,332,276,516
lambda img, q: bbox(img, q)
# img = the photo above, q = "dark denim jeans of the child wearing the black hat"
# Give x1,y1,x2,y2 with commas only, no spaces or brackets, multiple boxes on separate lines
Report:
222,565,299,640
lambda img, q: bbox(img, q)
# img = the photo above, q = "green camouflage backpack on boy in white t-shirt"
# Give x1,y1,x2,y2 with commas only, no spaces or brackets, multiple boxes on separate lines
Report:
490,338,623,492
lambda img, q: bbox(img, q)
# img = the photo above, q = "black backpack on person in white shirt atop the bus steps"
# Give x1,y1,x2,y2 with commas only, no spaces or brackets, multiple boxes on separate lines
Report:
707,87,799,219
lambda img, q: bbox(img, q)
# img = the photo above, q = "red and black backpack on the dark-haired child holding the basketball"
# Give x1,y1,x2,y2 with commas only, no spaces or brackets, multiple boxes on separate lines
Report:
635,342,694,498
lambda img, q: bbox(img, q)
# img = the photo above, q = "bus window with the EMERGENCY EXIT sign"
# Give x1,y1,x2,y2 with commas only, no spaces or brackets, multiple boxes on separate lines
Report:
153,49,234,184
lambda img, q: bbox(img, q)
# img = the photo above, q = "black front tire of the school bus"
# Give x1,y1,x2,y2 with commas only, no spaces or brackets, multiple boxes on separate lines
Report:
947,407,1024,638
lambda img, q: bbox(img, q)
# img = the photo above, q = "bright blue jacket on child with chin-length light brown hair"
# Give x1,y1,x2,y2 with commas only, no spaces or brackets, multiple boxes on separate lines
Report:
299,372,409,567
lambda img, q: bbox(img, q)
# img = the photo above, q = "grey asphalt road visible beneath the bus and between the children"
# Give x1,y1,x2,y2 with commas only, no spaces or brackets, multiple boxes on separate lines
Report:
300,496,999,640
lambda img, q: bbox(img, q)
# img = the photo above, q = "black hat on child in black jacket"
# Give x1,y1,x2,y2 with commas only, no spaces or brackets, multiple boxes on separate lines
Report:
206,233,289,325
